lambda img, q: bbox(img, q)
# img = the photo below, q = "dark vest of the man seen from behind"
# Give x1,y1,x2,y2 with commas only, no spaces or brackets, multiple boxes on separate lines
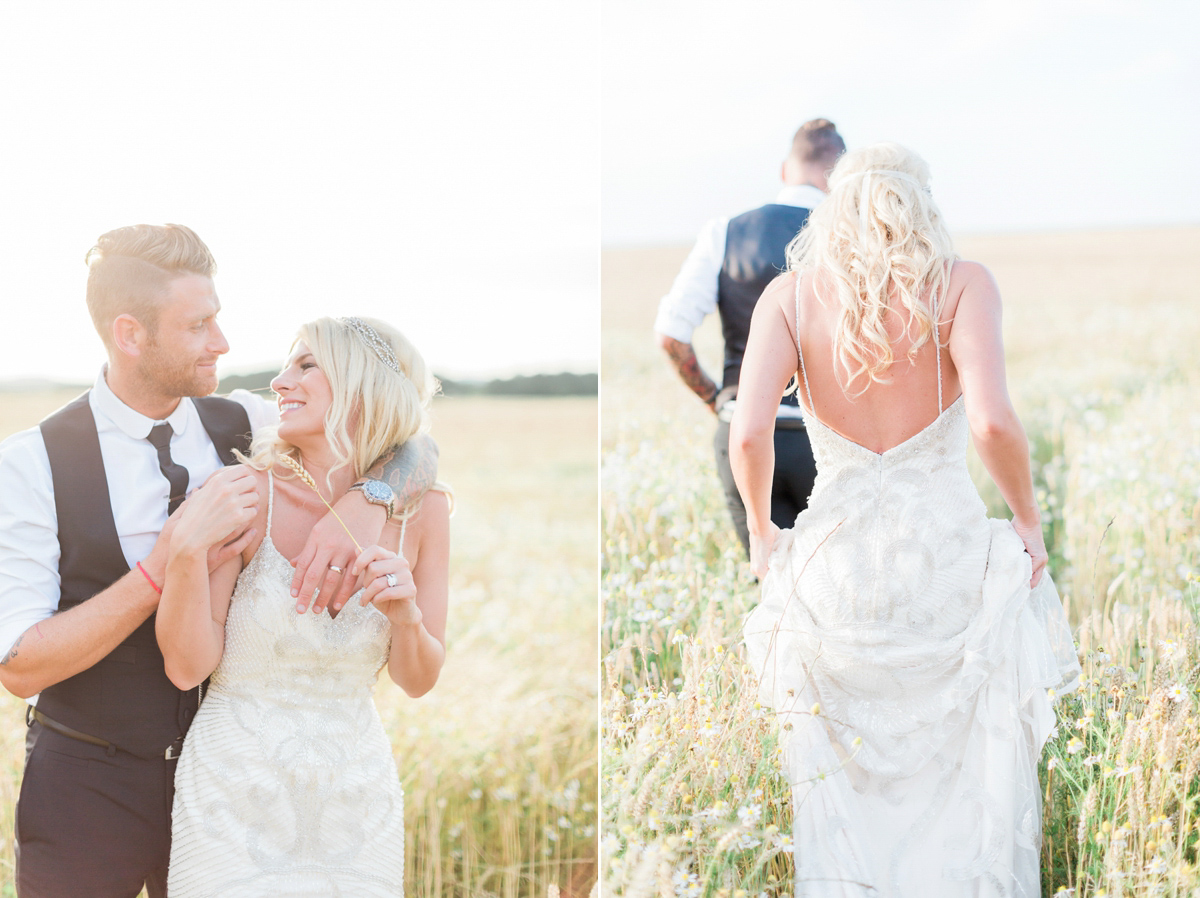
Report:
716,203,809,391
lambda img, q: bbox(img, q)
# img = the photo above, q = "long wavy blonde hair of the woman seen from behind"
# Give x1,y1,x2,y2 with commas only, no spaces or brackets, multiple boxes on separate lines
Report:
787,143,956,395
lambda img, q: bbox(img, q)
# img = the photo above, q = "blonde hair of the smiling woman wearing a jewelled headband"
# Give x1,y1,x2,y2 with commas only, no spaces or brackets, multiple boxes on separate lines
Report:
246,318,438,478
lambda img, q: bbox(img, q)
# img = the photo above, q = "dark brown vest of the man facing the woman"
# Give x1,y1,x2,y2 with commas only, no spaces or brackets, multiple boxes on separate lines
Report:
37,393,250,758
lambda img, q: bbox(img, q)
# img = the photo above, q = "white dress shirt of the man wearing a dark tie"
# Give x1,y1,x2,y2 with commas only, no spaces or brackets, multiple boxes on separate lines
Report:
0,370,278,651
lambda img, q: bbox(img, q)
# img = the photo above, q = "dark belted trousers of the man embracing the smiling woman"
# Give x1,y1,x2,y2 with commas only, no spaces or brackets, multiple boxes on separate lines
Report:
16,722,176,898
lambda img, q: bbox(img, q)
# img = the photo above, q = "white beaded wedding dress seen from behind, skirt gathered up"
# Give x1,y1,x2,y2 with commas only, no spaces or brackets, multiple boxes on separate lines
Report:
744,296,1080,898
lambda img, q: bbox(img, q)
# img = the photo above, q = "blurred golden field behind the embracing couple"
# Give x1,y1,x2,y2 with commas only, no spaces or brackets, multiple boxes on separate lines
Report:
0,391,598,898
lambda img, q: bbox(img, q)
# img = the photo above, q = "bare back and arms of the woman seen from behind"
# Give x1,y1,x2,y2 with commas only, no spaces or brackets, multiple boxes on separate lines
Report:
730,255,1045,582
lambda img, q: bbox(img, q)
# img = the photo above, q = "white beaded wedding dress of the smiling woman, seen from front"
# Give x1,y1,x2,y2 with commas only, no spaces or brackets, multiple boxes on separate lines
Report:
168,474,404,898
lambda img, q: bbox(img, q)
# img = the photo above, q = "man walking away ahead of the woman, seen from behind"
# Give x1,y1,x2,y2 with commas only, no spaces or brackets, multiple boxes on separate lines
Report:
654,119,846,555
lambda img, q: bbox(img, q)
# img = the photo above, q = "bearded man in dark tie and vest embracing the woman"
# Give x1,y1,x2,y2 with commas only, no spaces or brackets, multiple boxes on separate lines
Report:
0,225,436,898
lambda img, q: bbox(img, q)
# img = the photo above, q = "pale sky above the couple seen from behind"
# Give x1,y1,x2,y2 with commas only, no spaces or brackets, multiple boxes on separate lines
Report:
601,0,1200,246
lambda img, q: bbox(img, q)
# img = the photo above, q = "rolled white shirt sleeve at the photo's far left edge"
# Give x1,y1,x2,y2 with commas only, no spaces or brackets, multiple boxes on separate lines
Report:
0,427,60,652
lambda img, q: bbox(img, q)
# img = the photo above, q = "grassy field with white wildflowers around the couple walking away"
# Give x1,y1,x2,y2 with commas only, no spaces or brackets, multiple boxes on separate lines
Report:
600,228,1200,898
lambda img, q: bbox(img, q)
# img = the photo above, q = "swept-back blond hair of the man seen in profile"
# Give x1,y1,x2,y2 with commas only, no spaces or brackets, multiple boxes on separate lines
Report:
84,225,217,351
